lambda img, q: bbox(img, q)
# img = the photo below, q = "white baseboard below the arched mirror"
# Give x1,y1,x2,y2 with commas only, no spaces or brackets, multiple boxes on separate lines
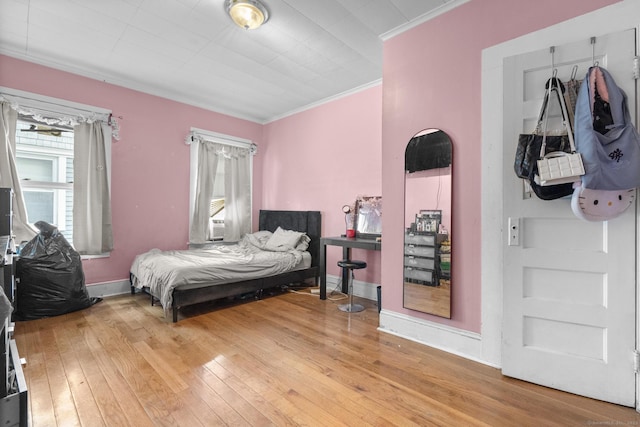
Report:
378,310,498,368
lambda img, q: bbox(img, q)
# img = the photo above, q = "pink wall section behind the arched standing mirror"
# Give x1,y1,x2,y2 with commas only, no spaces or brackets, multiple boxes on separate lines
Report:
382,0,615,332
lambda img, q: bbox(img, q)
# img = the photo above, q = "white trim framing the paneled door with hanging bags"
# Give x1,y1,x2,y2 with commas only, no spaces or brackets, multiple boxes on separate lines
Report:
481,0,640,409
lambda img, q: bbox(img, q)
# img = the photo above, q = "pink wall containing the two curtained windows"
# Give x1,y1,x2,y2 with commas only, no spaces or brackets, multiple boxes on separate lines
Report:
0,55,263,285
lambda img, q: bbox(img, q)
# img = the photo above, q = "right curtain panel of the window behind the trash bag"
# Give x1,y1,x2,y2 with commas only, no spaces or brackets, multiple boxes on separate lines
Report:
73,121,113,255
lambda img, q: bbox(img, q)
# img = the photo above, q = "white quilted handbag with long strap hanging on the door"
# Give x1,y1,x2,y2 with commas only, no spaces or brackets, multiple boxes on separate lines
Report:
534,76,584,186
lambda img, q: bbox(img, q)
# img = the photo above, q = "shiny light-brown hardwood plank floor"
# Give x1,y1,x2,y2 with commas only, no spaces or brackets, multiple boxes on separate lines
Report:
15,293,640,427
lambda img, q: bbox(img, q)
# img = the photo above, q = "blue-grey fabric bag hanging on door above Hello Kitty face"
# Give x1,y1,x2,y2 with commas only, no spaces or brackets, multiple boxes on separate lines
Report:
575,66,640,190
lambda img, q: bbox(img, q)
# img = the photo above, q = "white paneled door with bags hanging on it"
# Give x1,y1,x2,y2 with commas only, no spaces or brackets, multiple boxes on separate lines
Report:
502,30,637,406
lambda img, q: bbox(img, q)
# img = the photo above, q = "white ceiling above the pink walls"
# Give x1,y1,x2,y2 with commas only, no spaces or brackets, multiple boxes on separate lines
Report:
0,0,468,123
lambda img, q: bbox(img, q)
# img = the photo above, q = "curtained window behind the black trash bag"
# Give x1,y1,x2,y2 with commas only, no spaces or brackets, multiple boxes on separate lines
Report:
0,87,119,256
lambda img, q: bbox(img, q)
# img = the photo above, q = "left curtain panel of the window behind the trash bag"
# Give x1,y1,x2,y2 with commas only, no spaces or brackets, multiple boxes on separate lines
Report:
0,102,36,243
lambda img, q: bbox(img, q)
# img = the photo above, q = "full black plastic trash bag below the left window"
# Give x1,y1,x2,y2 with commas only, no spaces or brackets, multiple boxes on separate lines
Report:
14,221,102,320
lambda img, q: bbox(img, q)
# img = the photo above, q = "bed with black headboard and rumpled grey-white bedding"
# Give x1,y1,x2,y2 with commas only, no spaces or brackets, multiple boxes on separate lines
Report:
130,210,321,322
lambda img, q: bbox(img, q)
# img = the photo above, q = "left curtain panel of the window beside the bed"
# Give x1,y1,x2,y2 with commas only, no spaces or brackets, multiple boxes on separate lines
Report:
189,141,221,243
